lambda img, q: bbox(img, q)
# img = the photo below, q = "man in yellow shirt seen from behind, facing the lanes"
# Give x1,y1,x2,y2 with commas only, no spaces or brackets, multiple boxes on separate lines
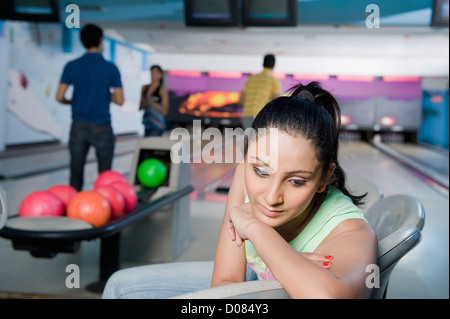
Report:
239,54,281,130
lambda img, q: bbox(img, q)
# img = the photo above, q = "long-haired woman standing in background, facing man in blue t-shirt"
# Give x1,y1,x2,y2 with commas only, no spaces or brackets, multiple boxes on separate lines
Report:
139,65,169,137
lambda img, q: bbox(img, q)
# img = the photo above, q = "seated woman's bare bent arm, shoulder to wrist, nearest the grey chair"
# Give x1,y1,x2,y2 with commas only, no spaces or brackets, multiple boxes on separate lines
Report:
246,220,376,298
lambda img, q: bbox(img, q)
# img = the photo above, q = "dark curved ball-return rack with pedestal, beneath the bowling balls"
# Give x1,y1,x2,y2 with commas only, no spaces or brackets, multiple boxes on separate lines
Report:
0,185,194,293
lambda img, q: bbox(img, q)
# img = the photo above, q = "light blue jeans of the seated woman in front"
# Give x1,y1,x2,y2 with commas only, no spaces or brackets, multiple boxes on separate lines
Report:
102,261,257,299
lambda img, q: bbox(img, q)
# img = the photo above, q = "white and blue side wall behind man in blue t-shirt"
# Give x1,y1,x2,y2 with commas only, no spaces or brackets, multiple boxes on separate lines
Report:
0,21,148,151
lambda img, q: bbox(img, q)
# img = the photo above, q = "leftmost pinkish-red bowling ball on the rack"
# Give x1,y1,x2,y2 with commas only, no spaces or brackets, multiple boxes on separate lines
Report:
19,191,65,217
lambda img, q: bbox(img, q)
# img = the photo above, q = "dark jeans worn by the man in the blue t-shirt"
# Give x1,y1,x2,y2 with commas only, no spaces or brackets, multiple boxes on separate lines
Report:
69,120,115,191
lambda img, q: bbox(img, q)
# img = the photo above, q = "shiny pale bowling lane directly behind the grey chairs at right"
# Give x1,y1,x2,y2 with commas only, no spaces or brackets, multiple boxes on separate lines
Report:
339,142,449,299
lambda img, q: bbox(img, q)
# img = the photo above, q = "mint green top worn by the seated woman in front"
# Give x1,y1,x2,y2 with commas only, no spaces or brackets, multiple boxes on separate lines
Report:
245,188,367,279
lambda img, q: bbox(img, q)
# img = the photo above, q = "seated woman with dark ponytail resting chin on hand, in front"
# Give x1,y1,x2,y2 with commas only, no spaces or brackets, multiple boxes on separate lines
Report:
103,82,377,298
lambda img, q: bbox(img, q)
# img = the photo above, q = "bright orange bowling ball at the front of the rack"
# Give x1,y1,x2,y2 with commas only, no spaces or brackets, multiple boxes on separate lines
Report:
66,191,111,227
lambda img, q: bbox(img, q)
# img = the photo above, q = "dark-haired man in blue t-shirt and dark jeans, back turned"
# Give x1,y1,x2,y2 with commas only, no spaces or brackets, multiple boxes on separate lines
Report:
56,24,124,191
